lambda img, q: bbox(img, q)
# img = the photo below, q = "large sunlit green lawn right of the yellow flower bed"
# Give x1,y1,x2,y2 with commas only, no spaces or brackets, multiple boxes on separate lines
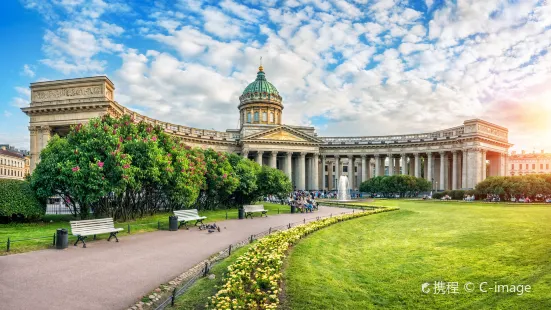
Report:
282,200,551,309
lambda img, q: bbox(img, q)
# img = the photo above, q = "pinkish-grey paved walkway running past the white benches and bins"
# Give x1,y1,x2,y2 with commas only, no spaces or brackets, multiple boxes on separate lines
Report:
0,207,351,310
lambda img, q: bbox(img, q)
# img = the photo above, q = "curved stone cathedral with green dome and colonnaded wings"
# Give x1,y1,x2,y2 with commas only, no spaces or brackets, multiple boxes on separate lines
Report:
22,66,511,190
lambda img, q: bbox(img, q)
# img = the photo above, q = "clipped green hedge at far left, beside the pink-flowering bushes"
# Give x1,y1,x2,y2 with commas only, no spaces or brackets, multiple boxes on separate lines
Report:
0,179,46,219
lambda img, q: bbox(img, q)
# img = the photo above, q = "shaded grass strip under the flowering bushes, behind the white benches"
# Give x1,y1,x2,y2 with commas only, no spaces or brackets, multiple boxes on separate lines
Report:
0,203,291,256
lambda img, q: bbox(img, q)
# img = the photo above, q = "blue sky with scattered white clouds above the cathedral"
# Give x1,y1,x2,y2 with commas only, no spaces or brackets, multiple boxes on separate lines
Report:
0,0,551,152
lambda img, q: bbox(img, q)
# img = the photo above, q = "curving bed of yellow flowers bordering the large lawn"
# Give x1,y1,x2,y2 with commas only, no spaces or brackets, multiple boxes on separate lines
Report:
207,208,399,309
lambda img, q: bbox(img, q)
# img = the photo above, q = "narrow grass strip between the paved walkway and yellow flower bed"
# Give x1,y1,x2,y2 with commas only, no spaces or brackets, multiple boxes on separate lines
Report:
174,245,249,310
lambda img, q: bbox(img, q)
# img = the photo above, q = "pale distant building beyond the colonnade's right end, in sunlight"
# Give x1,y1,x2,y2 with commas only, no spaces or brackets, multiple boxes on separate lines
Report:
509,150,551,175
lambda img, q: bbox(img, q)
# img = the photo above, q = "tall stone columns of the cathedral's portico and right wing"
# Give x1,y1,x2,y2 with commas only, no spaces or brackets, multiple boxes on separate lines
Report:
242,148,508,190
